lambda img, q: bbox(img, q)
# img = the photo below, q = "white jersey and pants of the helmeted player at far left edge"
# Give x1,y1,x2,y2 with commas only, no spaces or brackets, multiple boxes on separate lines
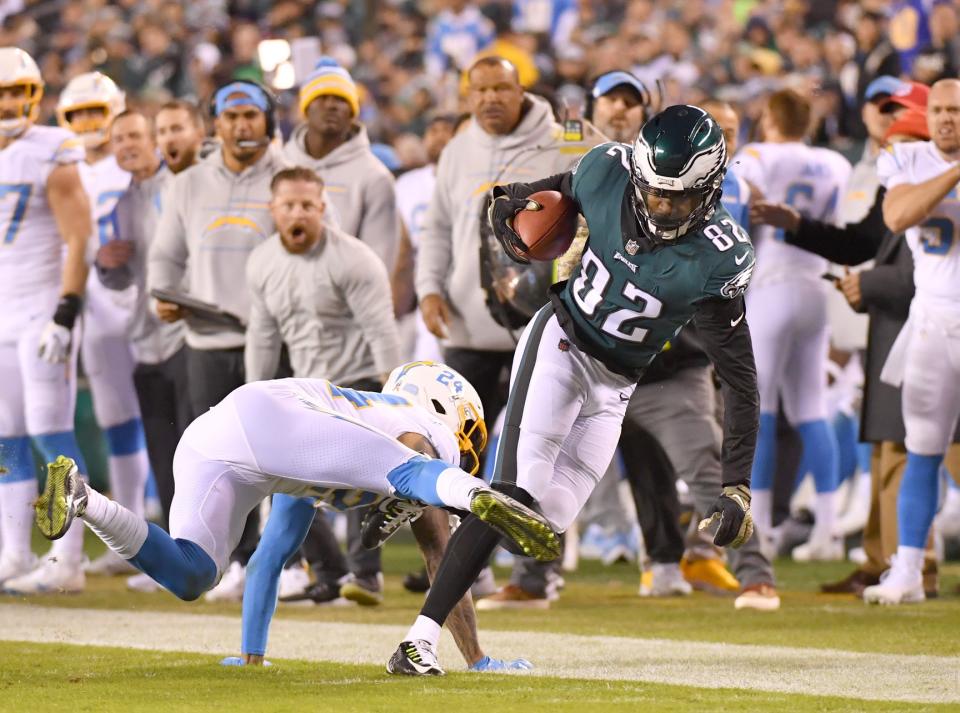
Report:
0,126,84,437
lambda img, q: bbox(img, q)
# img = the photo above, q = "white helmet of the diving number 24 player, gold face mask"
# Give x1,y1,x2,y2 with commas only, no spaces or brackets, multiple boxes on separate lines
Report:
383,361,487,475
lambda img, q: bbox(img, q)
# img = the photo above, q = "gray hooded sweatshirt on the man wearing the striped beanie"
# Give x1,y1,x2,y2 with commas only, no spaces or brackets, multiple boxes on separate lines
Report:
283,124,400,274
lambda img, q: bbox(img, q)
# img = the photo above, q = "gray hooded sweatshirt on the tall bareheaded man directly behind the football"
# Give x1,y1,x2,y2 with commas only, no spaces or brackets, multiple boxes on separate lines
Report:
416,94,589,351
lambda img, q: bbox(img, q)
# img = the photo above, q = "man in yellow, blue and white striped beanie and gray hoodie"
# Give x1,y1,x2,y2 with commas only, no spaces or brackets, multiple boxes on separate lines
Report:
283,58,400,273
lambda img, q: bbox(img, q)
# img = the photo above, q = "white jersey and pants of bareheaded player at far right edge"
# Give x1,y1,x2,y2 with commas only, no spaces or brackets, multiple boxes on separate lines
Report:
877,141,960,455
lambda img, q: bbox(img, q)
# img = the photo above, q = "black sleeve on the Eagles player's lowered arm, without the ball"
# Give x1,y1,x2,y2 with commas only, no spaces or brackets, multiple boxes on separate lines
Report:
694,296,760,486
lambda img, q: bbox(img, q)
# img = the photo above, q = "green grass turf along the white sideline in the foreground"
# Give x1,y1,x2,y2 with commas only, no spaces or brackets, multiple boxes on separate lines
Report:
0,538,960,712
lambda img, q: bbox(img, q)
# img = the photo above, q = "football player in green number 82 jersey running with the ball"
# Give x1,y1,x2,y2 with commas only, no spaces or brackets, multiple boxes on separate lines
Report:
387,106,759,675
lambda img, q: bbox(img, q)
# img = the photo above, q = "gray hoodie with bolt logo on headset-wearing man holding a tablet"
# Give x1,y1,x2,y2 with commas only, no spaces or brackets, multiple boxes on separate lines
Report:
147,146,285,349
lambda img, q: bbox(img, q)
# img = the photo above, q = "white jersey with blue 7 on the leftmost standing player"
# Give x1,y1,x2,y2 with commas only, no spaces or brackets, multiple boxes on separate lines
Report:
0,126,84,297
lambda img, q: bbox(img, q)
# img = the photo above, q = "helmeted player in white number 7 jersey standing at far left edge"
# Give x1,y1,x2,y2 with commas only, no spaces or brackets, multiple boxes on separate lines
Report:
0,47,90,590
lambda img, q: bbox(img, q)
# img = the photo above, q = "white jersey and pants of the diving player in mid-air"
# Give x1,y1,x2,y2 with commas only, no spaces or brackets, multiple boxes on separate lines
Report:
170,379,460,572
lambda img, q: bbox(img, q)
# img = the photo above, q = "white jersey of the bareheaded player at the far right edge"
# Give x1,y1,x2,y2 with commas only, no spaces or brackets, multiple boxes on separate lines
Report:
877,141,960,306
